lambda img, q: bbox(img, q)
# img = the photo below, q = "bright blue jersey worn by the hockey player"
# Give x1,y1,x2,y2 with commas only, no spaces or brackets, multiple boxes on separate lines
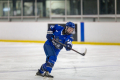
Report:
45,24,73,53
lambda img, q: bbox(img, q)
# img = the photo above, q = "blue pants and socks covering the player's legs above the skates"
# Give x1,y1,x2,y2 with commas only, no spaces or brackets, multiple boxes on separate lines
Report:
40,44,57,73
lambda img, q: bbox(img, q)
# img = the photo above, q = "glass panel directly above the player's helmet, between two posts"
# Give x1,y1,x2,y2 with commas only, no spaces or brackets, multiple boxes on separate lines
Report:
67,0,81,15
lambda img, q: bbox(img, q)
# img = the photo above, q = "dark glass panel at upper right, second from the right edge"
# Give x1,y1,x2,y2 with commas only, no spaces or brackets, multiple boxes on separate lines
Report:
100,0,115,14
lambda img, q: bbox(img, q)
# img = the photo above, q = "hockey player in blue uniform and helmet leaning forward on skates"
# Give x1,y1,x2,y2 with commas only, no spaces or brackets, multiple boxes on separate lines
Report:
36,22,75,78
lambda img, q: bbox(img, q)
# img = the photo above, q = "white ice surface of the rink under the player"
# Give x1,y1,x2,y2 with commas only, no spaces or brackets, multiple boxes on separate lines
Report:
0,42,120,80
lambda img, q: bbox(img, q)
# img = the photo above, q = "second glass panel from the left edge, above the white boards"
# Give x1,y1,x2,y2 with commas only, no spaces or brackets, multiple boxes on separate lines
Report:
9,0,21,16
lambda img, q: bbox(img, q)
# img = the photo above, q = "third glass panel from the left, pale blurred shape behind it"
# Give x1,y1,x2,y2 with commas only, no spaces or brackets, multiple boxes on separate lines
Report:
23,0,35,16
